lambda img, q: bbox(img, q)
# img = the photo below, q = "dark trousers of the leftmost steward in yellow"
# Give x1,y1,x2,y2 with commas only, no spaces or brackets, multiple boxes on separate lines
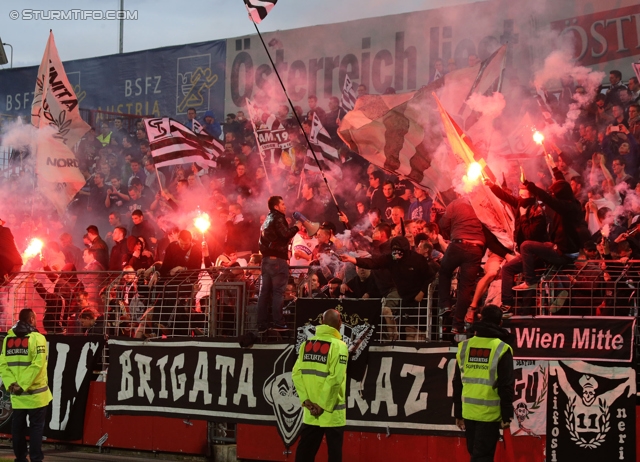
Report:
11,406,47,462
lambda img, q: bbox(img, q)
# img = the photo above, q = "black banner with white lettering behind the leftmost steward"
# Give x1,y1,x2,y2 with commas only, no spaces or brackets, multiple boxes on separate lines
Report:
0,335,104,440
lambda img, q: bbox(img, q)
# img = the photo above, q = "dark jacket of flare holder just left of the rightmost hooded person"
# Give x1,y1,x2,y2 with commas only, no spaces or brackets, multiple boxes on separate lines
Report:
491,185,549,247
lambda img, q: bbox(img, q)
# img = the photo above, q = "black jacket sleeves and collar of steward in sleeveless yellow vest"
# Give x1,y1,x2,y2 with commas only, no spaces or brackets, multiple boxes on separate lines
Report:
453,321,515,422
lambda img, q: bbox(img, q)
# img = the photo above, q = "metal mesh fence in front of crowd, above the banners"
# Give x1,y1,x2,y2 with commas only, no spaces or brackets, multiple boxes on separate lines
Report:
5,261,640,343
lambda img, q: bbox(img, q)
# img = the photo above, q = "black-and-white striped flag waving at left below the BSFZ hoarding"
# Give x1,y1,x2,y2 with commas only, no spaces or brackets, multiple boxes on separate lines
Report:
144,117,224,168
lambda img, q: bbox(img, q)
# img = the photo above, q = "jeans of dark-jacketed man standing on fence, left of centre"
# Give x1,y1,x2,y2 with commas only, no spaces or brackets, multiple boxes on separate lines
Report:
258,257,289,328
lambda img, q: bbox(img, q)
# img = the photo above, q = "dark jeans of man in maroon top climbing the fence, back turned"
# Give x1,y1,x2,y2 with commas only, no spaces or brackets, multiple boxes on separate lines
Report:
438,242,484,328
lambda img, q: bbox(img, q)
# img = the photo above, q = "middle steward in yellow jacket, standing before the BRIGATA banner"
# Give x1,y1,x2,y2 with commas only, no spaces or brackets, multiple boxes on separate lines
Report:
292,310,349,462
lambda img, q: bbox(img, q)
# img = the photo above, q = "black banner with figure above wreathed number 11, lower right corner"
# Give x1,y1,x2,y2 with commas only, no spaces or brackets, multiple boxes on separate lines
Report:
546,361,636,462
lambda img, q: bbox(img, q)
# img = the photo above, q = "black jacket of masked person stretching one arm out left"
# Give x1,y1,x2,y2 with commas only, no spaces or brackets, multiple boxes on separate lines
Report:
356,236,436,302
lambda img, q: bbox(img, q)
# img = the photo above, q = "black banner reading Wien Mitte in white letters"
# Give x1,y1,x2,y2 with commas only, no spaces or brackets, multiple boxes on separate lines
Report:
504,316,636,362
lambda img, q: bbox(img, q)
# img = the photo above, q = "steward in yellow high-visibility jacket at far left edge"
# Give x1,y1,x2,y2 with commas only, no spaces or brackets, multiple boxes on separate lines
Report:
0,308,52,462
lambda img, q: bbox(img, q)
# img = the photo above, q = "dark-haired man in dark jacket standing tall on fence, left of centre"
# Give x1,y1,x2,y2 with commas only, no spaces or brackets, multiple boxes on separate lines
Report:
258,196,298,333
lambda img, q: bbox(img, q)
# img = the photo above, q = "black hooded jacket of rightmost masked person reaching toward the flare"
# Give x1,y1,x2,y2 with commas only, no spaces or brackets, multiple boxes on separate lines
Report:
526,180,587,254
